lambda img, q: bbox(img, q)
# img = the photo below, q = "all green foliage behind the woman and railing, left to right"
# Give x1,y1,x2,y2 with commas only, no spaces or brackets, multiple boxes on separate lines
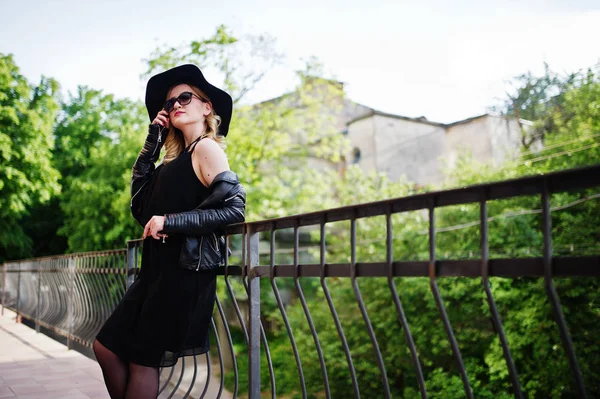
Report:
0,26,600,398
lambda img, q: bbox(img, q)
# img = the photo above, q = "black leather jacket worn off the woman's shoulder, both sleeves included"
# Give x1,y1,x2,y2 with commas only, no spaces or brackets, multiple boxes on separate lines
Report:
130,124,246,271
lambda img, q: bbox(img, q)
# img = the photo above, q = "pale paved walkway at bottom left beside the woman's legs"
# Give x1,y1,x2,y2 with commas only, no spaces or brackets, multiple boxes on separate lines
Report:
0,309,109,399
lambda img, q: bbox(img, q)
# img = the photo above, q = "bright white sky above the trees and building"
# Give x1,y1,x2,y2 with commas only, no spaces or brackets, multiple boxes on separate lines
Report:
0,0,600,122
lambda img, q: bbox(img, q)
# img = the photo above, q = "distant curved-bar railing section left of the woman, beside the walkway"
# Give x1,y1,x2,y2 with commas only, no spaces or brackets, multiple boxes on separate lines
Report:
1,249,127,348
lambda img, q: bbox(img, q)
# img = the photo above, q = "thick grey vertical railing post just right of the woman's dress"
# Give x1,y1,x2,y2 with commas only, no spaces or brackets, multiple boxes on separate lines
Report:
245,225,260,399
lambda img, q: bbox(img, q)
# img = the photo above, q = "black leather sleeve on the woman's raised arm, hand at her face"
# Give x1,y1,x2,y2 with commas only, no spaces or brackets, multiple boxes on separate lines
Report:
129,124,166,226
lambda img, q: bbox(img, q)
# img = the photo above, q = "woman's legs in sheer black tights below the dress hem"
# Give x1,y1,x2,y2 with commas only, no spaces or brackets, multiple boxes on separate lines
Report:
94,341,158,399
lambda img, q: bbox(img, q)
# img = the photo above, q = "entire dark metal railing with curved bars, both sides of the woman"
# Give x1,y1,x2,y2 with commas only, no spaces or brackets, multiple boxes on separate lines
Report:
1,165,600,398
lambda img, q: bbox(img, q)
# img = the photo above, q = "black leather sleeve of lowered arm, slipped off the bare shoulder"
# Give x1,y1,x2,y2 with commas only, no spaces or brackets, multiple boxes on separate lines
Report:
161,171,246,235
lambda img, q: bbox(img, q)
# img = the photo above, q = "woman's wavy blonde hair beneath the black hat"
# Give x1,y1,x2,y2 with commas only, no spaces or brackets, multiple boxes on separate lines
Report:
162,85,227,165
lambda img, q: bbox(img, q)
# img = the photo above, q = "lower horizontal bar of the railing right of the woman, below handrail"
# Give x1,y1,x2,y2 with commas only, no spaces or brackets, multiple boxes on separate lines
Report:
247,256,600,277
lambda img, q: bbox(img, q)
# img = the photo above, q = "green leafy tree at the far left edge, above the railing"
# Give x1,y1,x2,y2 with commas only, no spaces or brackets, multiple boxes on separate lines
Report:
0,54,60,262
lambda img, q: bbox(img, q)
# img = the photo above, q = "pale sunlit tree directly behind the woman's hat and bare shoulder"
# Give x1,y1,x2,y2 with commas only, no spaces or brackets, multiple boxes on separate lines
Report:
145,26,348,220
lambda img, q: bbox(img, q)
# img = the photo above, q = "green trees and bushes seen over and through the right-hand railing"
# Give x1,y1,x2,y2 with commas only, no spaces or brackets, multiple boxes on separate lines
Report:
264,63,600,398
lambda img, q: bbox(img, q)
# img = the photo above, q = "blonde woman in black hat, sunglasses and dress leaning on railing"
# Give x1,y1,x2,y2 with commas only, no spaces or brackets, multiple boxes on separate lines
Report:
93,65,245,398
